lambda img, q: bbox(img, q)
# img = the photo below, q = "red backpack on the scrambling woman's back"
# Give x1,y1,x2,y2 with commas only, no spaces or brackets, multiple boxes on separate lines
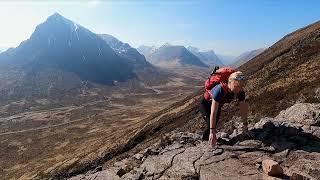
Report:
204,66,235,101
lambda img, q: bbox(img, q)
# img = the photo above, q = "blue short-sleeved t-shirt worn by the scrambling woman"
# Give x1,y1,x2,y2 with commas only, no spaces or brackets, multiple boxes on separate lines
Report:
210,84,246,103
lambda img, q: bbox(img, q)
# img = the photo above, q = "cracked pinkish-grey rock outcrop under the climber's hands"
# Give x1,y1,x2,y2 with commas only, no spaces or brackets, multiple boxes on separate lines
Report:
71,104,320,180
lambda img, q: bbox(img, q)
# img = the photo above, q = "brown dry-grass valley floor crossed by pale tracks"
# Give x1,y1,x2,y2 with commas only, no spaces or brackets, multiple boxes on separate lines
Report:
0,67,202,179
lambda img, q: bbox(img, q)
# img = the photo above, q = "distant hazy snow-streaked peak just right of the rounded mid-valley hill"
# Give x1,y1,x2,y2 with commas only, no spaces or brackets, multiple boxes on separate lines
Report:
187,46,224,66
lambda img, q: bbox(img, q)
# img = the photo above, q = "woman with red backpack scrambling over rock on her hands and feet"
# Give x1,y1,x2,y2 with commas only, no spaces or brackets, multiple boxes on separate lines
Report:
200,67,248,147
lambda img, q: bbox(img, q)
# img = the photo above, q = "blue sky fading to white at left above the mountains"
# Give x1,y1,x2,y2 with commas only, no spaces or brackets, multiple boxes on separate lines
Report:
0,0,320,56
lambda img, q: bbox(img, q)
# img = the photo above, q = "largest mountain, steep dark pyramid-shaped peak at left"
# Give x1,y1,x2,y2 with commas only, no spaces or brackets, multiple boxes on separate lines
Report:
0,13,134,84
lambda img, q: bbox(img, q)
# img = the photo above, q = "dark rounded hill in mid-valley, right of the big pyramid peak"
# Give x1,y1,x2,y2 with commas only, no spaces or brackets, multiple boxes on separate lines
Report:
138,43,208,67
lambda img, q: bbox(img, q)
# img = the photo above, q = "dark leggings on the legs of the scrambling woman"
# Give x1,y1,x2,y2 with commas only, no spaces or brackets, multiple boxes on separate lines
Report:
199,97,221,130
